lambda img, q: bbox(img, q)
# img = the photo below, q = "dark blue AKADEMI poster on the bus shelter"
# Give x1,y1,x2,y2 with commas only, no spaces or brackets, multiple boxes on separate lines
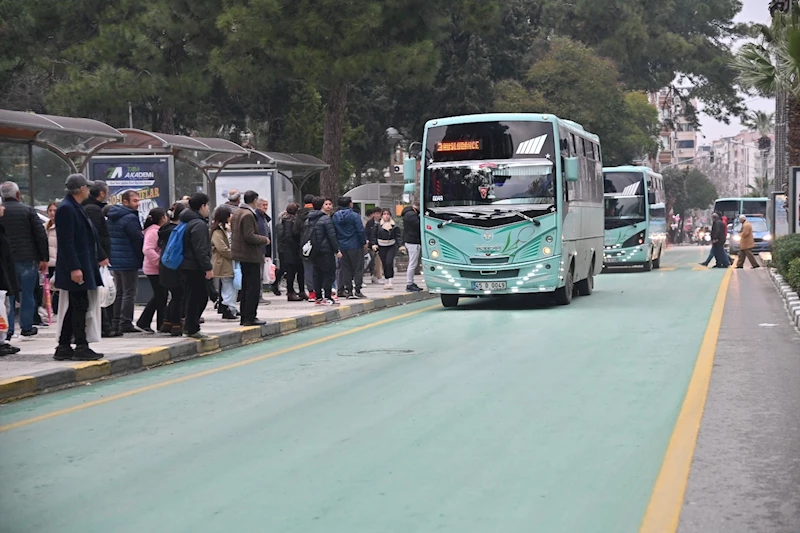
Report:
90,156,172,226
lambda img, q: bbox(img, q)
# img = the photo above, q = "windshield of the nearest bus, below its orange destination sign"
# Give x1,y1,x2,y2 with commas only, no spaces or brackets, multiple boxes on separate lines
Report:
425,161,556,208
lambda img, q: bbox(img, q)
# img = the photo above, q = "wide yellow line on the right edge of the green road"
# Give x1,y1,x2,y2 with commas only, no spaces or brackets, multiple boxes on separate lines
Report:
639,269,732,533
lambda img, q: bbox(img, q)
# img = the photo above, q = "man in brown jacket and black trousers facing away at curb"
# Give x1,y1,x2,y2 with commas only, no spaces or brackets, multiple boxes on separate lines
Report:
231,191,270,326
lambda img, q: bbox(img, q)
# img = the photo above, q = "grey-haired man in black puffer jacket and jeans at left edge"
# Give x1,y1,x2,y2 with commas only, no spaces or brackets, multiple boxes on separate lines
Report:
0,181,50,338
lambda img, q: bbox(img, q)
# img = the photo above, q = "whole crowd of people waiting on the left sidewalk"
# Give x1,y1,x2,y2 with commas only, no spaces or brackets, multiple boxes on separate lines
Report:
0,174,421,361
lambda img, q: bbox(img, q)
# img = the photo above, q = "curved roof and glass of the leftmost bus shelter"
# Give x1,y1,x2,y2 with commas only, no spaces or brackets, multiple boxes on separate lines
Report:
0,109,124,206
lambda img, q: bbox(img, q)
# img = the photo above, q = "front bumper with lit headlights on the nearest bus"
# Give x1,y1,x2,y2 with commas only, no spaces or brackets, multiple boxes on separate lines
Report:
422,256,564,297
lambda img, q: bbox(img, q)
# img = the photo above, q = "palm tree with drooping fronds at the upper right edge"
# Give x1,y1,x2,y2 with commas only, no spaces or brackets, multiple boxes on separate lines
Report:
733,7,800,190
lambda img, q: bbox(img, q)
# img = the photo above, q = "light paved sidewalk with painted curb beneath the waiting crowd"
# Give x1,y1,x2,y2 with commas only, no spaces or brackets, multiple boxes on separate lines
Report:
0,277,430,402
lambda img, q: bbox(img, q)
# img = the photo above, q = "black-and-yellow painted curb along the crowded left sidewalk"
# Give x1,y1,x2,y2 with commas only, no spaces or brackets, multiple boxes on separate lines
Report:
0,291,433,403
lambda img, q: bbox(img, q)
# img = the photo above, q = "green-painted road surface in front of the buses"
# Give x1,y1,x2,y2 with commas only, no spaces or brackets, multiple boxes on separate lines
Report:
0,248,797,533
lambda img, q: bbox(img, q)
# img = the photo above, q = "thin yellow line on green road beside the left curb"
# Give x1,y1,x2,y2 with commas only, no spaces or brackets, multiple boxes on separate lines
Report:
0,304,440,433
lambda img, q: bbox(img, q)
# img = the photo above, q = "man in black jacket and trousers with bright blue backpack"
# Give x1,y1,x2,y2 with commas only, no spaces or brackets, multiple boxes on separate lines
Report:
180,192,214,339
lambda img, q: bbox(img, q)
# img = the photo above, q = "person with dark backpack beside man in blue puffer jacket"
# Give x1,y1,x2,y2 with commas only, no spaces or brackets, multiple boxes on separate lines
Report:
301,197,342,305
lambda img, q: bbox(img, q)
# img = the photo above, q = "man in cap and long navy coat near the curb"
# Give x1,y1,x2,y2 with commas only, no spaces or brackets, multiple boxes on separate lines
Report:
53,174,108,361
